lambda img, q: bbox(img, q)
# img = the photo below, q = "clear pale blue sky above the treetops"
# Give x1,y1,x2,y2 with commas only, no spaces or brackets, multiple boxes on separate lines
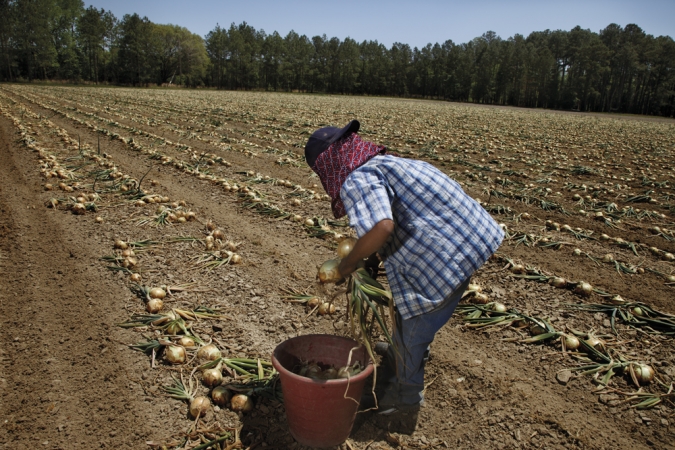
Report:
84,0,675,47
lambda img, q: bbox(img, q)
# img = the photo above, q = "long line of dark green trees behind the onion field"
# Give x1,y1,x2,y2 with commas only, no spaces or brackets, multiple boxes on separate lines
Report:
0,0,675,117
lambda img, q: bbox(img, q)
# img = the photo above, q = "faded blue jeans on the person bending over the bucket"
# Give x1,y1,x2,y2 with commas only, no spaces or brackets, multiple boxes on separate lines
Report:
378,280,469,407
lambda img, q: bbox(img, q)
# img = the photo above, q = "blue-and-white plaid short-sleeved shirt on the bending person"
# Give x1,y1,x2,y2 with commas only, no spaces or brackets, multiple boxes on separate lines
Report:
340,155,504,319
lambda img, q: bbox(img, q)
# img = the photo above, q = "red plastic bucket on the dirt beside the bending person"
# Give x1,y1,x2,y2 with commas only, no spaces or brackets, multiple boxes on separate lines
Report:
272,334,373,447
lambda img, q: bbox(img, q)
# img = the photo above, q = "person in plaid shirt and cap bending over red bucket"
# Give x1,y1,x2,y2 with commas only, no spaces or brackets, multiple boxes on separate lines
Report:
305,120,504,432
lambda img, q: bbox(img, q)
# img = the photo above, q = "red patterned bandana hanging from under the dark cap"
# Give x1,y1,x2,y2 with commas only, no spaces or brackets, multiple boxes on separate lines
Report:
312,133,387,219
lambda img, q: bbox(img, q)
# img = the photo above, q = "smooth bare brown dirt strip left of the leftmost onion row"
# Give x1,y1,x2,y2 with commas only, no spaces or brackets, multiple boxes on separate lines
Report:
0,118,162,450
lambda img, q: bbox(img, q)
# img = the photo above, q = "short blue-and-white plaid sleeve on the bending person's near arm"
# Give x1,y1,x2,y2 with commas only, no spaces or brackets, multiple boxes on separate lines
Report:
340,166,394,238
